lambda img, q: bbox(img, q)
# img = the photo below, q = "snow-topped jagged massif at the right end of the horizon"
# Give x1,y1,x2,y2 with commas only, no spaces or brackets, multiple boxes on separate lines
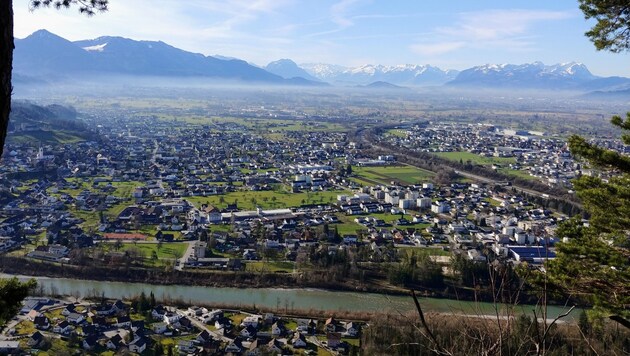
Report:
448,62,598,89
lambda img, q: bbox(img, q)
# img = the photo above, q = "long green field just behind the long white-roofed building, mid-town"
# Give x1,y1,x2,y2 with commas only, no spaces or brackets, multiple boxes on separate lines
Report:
186,190,350,210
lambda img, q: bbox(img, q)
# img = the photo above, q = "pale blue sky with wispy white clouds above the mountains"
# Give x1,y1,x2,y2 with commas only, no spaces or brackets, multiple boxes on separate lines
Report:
13,0,630,77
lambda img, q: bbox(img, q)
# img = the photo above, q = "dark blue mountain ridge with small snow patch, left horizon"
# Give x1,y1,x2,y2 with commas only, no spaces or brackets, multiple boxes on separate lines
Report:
14,30,320,85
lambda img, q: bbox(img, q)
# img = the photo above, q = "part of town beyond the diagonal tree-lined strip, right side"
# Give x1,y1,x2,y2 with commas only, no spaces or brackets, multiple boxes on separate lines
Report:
378,122,630,192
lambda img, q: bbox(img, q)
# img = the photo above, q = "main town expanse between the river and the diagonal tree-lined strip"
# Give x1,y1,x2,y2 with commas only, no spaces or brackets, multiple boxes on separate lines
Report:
0,101,568,272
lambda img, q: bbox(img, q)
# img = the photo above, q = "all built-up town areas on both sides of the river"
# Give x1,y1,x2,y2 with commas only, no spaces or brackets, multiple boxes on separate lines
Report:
0,98,622,355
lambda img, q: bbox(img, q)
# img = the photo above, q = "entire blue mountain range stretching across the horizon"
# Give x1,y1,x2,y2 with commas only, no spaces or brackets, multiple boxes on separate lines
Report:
13,30,630,93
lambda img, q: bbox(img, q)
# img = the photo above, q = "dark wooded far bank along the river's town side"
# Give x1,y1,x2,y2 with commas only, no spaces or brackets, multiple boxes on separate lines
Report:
0,256,584,306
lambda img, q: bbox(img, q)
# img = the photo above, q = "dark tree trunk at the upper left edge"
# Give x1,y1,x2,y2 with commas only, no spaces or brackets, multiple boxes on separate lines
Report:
0,0,14,156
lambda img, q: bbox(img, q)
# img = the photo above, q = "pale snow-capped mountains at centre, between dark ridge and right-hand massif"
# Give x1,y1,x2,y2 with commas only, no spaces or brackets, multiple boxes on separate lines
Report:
302,63,458,85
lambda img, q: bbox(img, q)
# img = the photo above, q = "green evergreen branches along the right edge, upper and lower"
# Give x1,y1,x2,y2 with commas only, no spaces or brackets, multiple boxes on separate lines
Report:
546,0,630,329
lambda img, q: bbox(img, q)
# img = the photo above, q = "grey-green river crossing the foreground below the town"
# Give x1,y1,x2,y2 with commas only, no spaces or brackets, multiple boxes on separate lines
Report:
0,274,579,321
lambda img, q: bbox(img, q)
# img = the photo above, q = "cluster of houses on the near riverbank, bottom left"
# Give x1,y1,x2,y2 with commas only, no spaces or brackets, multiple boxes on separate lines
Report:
0,294,366,355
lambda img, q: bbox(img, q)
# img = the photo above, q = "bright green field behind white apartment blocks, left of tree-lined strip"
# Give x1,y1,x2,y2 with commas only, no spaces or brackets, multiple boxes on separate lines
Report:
352,166,435,185
